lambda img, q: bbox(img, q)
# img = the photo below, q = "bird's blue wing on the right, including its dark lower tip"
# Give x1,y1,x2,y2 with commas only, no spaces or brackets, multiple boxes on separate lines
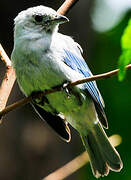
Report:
63,48,108,128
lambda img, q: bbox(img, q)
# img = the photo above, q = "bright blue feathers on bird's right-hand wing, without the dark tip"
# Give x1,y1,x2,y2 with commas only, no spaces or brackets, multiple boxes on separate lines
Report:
64,50,103,110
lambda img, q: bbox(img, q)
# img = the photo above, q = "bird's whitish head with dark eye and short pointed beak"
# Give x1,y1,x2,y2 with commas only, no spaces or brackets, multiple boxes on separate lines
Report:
14,5,69,33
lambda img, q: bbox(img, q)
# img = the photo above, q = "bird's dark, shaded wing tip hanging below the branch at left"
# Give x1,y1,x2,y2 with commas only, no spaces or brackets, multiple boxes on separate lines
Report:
32,103,71,142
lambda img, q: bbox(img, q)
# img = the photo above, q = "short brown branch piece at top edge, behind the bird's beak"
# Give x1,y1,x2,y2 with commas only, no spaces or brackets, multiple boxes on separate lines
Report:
57,0,79,15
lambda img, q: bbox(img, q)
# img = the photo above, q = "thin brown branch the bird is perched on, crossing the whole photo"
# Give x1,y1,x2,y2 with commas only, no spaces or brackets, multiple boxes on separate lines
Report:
0,64,131,117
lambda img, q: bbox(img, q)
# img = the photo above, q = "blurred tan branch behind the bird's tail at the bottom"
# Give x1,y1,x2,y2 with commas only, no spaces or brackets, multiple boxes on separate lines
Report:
42,135,122,180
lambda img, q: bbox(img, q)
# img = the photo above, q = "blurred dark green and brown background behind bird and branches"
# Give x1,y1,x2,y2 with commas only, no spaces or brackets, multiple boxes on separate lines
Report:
0,0,131,180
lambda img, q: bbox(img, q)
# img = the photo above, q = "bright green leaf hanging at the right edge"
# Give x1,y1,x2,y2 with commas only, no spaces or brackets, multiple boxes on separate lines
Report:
118,19,131,81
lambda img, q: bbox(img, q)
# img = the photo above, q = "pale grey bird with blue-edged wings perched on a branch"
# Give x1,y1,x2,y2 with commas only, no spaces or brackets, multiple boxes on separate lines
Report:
11,5,123,178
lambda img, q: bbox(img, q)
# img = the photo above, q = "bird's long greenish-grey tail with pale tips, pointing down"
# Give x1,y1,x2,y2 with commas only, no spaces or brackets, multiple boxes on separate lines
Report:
81,123,123,178
